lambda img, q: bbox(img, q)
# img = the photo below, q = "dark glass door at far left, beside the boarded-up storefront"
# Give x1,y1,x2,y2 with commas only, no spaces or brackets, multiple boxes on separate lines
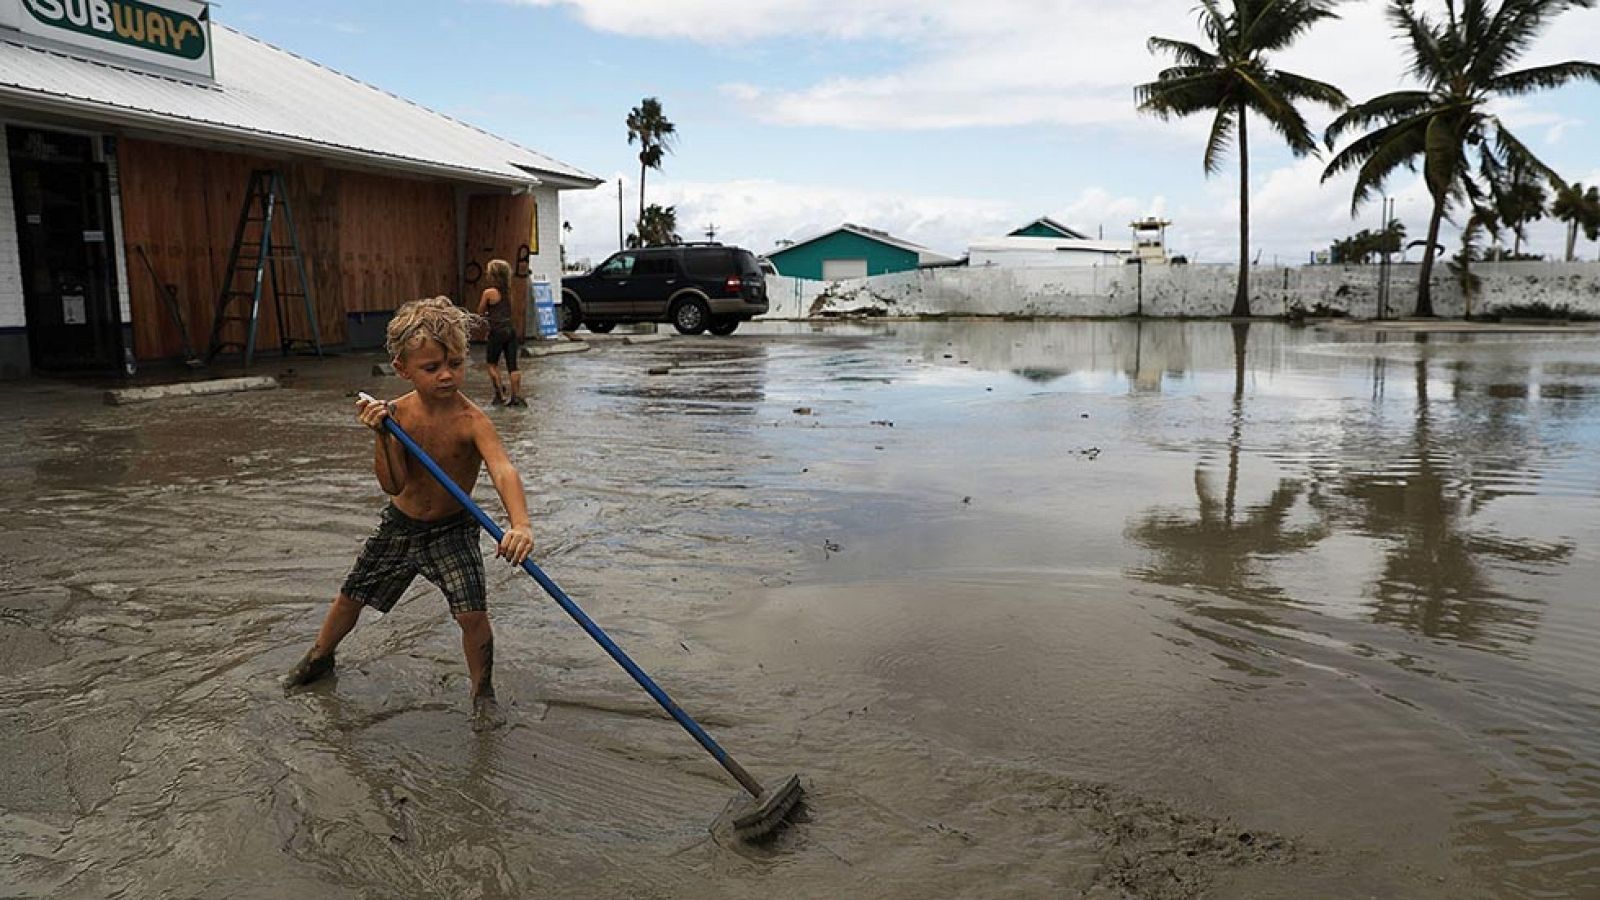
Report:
6,127,122,372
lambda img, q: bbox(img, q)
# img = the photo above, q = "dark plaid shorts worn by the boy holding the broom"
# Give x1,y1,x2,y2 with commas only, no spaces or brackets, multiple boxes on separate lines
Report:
341,504,488,613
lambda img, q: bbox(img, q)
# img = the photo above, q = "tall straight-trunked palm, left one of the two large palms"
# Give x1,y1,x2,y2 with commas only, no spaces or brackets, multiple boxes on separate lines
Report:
1133,0,1349,315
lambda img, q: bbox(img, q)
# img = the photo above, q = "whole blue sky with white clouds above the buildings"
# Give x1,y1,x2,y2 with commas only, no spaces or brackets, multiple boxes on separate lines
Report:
225,0,1600,263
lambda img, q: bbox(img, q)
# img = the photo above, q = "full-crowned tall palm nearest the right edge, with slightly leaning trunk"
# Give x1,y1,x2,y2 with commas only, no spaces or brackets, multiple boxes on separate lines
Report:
1322,0,1600,315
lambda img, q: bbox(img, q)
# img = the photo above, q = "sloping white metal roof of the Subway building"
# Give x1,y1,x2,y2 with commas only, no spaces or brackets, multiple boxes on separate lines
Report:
0,22,600,187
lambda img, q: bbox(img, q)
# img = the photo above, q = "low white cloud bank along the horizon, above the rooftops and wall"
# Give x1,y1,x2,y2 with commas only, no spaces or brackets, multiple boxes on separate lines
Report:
562,159,1600,264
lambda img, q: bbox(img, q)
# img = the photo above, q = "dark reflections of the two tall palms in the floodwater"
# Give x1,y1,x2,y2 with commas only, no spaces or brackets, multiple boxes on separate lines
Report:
1128,323,1574,650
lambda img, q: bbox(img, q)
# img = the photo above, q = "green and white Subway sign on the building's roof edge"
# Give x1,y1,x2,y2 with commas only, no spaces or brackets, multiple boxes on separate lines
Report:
0,0,211,78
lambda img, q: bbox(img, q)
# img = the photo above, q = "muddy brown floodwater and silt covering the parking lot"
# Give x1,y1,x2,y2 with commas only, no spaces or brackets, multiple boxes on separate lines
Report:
0,322,1600,898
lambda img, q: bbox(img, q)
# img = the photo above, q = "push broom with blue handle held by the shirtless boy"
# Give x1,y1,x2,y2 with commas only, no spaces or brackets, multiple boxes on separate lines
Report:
360,392,802,841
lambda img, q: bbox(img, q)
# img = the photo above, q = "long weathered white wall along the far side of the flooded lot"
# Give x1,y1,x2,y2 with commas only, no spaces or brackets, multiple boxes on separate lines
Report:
766,263,1600,319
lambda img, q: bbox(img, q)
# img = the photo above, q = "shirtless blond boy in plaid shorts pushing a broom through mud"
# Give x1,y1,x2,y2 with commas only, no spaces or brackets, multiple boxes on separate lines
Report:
283,296,533,730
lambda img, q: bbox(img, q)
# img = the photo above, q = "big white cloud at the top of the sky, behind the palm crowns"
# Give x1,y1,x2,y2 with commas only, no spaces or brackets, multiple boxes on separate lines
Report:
509,0,1600,130
